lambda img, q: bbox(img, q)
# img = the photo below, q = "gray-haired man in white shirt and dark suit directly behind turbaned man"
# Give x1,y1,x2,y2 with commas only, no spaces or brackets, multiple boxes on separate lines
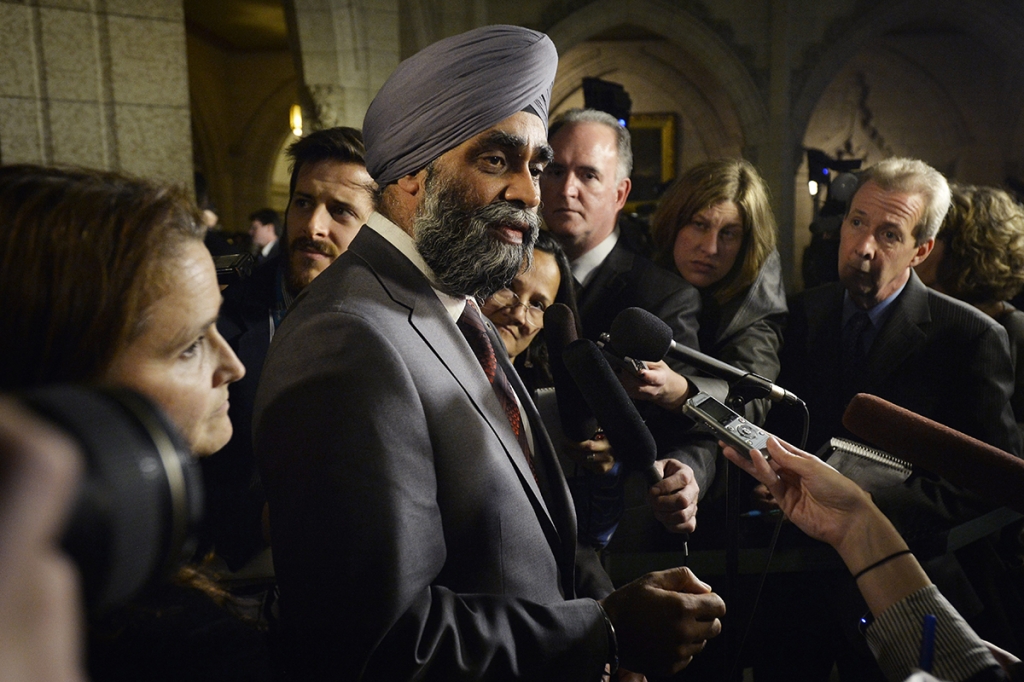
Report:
541,109,716,550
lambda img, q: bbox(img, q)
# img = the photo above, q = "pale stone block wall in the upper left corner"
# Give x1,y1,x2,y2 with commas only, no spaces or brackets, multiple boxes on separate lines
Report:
0,0,193,186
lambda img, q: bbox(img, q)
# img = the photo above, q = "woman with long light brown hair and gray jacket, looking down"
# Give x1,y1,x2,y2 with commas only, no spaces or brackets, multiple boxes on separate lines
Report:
622,159,786,424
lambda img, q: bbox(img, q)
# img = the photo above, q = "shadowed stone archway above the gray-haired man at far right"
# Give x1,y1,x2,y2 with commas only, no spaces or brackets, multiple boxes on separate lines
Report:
792,2,1024,286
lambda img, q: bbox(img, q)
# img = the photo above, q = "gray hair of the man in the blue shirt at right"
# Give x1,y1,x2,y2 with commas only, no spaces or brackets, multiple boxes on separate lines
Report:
854,158,950,246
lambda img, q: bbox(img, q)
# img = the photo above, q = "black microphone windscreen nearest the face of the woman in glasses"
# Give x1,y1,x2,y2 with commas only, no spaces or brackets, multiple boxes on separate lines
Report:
544,303,597,442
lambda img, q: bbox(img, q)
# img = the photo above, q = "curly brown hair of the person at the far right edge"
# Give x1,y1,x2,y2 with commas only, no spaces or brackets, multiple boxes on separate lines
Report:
936,185,1024,304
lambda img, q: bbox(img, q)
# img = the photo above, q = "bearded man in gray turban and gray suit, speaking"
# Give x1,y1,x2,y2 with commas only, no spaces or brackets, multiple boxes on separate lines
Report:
255,27,724,682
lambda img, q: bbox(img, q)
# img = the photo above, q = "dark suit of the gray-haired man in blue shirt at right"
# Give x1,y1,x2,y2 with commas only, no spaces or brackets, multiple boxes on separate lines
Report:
758,271,1020,680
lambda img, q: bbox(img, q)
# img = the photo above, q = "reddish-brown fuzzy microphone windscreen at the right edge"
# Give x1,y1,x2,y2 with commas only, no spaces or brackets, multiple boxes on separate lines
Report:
843,393,1024,513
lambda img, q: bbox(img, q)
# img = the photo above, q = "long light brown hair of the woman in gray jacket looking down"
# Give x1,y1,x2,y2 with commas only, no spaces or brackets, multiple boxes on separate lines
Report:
651,159,777,303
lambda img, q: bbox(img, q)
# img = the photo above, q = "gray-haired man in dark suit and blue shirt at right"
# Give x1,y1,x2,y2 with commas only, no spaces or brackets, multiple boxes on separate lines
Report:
758,159,1021,680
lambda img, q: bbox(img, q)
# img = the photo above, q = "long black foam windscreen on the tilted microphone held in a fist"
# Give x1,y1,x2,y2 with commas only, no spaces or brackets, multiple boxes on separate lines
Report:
563,339,657,470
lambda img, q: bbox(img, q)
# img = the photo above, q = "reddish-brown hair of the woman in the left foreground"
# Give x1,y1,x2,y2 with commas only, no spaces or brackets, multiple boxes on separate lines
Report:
0,165,205,390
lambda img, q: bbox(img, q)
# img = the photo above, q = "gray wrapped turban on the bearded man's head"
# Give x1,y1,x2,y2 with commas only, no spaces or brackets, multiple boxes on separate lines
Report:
362,26,558,187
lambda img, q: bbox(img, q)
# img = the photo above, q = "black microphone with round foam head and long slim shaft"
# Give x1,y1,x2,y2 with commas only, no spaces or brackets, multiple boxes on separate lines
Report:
605,308,804,406
